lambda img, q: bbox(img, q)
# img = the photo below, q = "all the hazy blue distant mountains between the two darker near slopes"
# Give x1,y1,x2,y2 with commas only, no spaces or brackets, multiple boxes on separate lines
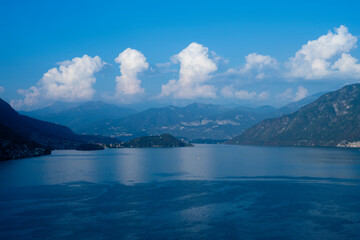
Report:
23,94,319,141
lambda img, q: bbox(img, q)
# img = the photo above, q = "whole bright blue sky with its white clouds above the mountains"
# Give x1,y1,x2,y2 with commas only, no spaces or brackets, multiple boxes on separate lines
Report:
0,1,360,109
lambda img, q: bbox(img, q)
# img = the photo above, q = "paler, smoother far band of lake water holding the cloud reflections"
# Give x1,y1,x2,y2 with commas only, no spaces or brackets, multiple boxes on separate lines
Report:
0,145,360,186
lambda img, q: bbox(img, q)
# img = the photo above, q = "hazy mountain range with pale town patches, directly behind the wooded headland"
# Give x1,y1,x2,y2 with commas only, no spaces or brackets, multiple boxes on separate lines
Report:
71,96,322,141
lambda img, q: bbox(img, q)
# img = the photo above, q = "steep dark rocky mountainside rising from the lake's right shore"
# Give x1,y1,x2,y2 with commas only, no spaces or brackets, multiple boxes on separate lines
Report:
227,84,360,147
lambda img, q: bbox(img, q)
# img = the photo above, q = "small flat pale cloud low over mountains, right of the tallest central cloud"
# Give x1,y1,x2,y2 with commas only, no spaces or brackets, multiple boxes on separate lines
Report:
221,85,269,100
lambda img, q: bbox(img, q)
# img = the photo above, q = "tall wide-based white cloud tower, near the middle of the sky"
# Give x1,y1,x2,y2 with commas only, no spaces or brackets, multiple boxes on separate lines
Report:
160,42,217,99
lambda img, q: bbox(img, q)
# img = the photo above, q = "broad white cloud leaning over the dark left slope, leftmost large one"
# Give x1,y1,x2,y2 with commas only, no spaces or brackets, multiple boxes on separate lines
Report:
11,55,105,108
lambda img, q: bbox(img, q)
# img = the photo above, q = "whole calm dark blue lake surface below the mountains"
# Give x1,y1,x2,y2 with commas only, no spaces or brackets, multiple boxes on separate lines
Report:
0,145,360,239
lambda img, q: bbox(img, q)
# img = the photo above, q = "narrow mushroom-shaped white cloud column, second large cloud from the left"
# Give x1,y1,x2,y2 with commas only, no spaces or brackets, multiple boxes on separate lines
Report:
115,48,149,96
